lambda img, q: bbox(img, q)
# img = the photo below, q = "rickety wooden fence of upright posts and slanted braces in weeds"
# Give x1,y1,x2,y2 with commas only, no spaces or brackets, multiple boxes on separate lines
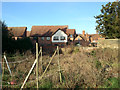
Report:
1,43,62,90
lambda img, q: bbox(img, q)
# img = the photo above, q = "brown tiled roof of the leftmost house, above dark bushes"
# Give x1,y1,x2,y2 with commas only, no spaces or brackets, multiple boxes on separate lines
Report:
8,27,27,37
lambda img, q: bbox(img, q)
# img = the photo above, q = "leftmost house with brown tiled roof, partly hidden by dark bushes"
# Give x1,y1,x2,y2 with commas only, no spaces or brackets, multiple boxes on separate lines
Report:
8,27,27,40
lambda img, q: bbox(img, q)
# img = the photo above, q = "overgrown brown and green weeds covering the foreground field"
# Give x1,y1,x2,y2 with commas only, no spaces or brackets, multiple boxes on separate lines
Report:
3,47,120,89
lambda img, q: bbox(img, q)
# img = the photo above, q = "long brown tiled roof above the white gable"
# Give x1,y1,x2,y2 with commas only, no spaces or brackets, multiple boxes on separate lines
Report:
30,25,68,36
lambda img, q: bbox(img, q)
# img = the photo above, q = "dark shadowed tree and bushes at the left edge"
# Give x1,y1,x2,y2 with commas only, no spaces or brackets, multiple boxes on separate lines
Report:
0,21,33,53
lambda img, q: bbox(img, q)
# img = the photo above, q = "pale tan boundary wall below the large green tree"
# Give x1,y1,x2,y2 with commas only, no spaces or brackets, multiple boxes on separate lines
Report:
97,39,120,48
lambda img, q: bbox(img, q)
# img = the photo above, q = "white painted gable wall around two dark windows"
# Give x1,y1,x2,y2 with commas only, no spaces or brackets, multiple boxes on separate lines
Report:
52,30,68,43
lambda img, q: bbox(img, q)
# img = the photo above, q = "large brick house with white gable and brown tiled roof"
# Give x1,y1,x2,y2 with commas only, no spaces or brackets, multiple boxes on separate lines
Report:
30,25,76,46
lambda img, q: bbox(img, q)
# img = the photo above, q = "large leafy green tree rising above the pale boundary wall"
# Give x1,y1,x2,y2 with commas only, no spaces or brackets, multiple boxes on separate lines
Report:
95,2,120,39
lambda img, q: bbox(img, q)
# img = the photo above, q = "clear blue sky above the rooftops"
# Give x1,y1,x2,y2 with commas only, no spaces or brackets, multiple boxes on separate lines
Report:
2,2,114,34
